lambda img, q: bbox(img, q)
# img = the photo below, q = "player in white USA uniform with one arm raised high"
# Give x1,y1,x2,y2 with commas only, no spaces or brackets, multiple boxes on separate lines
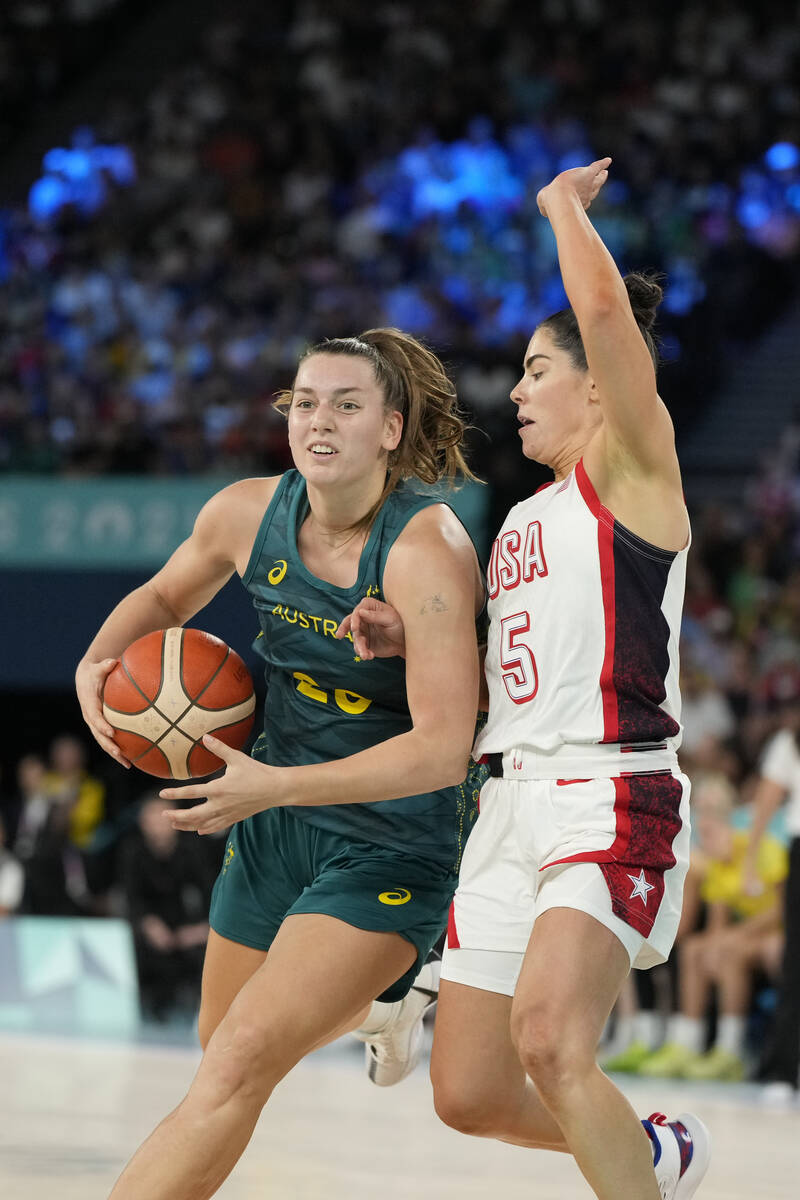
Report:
351,158,709,1200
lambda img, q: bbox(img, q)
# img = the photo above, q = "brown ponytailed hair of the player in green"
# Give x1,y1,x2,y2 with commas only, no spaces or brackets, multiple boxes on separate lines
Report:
275,329,476,530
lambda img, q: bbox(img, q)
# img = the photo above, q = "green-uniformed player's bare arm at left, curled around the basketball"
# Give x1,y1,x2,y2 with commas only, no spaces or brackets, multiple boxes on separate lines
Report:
76,479,277,766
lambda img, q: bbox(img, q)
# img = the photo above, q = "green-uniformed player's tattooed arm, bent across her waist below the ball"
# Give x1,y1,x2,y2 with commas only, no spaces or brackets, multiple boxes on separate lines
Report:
161,505,482,833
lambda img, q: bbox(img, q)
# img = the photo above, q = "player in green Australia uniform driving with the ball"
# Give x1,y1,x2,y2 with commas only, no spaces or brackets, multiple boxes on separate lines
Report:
76,330,483,1200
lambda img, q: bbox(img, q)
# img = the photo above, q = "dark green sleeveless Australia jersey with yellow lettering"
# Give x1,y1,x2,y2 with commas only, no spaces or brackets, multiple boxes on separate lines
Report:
243,470,485,869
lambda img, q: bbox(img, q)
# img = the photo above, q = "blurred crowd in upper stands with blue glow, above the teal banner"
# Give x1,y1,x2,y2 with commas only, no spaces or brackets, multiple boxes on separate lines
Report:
0,0,800,488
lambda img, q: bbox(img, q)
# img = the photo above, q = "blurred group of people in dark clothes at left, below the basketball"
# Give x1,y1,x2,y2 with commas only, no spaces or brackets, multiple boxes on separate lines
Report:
0,734,222,1021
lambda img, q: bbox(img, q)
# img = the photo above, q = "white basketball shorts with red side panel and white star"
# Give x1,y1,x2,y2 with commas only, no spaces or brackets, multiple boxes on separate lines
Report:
441,770,690,996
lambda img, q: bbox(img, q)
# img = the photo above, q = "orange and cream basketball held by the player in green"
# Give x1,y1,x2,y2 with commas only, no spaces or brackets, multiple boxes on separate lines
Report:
103,629,255,779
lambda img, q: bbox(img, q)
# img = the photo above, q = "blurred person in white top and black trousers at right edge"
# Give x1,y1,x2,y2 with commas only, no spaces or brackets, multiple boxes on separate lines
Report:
745,701,800,1100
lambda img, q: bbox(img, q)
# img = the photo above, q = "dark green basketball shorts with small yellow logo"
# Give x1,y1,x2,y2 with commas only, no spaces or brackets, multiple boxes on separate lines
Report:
209,808,457,1001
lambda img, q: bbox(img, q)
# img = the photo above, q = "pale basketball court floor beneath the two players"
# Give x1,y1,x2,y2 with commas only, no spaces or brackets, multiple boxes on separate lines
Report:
0,1034,800,1200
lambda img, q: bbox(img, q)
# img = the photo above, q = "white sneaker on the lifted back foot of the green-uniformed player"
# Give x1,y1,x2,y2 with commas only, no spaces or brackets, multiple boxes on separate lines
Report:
356,958,441,1087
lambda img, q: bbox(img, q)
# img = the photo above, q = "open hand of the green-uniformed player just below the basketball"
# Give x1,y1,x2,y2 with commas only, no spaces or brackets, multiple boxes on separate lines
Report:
158,733,279,834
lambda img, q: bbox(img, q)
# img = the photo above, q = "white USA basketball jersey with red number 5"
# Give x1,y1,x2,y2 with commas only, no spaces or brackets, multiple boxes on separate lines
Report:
475,461,688,779
